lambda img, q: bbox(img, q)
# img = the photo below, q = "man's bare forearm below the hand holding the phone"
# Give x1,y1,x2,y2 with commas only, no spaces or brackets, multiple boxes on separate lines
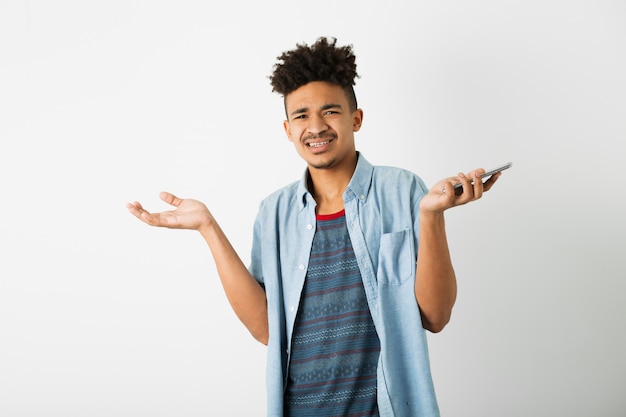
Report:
415,212,457,332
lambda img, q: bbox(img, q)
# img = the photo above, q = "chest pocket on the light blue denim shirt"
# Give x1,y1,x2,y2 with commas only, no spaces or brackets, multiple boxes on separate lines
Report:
377,228,415,285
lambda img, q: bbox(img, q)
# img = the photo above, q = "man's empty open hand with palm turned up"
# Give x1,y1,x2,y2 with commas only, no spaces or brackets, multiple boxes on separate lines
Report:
126,191,212,230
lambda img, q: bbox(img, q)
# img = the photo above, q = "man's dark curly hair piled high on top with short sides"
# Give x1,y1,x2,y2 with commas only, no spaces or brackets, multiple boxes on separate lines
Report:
269,37,359,111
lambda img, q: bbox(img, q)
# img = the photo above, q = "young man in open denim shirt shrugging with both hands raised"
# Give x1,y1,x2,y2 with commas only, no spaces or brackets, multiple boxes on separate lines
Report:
128,38,500,417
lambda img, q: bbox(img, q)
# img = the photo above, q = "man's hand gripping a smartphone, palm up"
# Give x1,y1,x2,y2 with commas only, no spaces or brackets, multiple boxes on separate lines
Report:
420,168,502,213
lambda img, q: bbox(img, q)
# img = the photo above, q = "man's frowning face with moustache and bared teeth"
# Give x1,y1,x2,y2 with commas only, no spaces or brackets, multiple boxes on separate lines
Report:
283,81,363,169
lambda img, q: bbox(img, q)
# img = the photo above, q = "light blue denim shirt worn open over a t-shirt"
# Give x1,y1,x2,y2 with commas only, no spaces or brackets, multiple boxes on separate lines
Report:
250,155,439,417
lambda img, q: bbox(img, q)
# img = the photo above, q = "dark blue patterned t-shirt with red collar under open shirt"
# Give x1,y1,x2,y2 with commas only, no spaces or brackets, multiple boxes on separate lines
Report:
285,210,380,417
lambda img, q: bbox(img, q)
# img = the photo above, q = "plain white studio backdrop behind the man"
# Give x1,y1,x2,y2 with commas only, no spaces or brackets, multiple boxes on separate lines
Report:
0,0,626,417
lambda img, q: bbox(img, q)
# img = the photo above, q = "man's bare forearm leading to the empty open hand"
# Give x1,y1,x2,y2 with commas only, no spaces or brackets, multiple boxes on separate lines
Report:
199,219,269,345
